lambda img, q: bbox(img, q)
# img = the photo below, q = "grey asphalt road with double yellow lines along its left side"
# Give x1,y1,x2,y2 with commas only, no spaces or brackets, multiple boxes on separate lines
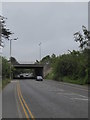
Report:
2,80,88,120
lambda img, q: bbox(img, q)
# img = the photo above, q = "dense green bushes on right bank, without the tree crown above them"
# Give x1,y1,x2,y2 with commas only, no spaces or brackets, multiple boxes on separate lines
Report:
45,49,90,84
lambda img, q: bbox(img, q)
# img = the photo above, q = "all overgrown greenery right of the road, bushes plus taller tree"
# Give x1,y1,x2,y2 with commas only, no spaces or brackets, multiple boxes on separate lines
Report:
41,26,90,84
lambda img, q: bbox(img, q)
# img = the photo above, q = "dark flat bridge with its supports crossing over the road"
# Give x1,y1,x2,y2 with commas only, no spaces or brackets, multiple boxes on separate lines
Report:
13,64,43,78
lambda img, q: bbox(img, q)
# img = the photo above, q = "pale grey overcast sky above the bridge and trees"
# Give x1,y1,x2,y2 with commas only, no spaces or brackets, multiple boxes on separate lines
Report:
2,2,88,62
